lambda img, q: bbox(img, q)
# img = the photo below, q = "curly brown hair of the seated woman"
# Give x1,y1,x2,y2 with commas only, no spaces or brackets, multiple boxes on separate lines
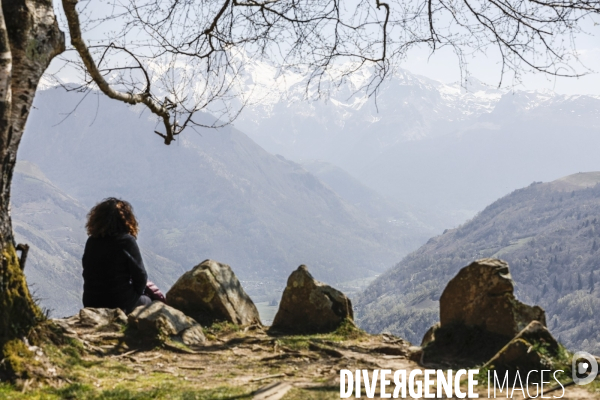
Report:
85,197,139,238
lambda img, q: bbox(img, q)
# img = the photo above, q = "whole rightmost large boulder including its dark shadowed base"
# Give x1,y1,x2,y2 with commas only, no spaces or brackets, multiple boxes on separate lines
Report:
422,258,558,367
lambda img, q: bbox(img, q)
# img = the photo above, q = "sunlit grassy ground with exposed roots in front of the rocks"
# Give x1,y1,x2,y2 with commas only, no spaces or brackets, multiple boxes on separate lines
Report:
0,318,600,400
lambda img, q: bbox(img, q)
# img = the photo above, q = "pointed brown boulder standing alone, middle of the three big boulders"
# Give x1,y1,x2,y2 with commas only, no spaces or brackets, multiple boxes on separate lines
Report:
271,265,354,333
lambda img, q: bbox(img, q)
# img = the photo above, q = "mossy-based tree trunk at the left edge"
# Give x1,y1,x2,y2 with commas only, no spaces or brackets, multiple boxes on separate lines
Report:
0,0,65,360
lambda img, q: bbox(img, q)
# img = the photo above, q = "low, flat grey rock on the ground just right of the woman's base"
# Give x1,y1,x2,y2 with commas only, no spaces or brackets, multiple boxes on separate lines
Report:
127,301,205,345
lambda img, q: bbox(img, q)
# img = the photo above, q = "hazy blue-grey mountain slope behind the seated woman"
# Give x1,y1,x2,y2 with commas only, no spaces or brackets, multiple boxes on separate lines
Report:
12,89,434,315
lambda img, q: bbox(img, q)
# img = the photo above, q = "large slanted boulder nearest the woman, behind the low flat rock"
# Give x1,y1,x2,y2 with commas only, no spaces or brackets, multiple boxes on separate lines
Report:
167,260,260,326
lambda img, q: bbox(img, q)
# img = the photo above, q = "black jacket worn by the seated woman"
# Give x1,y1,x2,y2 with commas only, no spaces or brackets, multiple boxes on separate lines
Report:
82,234,148,312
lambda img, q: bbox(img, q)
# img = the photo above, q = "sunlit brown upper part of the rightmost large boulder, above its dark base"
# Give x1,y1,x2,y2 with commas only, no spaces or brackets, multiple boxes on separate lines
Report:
440,258,546,339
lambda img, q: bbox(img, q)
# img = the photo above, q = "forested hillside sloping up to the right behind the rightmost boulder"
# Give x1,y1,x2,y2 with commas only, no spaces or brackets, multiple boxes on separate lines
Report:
357,172,600,354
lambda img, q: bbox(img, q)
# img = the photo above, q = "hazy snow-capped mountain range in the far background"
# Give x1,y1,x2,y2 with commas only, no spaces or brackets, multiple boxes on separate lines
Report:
235,61,600,230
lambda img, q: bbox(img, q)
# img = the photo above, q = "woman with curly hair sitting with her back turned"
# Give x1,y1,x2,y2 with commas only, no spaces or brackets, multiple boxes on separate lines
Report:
82,197,164,313
